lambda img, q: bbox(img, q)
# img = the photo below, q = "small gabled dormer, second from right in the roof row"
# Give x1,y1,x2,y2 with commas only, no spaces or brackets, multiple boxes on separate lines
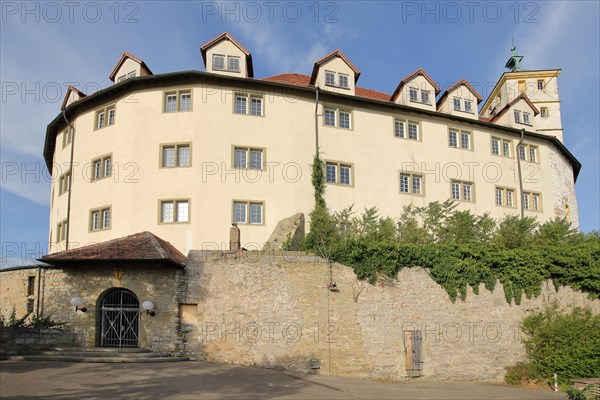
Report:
437,79,483,120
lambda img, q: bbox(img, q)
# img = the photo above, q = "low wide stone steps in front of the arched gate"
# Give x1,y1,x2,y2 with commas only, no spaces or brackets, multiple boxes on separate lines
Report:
0,347,189,363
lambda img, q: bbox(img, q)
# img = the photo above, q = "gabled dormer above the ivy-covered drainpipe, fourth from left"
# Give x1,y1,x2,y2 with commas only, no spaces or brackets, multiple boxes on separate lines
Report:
310,50,360,96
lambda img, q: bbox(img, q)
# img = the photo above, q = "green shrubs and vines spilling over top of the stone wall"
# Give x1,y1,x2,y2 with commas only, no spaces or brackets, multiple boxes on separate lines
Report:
307,202,600,304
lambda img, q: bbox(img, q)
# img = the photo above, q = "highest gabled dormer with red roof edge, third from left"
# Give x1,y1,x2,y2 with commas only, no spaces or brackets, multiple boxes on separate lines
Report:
200,32,254,78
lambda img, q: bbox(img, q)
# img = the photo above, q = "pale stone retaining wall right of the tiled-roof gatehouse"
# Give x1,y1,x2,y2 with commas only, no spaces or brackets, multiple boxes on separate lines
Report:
180,252,600,381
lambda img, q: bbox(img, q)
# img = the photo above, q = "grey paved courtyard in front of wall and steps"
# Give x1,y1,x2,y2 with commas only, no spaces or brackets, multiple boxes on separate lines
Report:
0,361,566,400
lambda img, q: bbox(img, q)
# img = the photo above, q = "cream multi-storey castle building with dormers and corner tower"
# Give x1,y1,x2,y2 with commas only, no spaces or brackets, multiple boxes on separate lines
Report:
44,33,581,254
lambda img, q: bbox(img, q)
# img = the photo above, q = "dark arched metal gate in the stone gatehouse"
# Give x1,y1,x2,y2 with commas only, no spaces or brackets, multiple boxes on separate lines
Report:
100,289,140,347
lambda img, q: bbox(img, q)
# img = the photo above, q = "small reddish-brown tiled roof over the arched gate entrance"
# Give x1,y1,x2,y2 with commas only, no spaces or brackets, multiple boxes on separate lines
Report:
40,232,187,268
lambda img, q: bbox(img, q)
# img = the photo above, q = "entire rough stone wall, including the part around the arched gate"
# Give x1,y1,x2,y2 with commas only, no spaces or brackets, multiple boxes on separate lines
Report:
0,255,600,381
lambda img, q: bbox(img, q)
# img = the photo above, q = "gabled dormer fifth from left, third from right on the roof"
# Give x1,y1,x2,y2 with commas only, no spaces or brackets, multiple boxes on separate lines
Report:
391,68,440,111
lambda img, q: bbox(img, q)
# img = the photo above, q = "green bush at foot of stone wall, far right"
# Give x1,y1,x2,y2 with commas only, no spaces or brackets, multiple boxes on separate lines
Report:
506,303,600,384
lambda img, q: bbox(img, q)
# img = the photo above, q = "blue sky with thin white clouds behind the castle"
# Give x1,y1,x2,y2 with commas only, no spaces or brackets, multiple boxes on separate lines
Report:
0,1,600,265
